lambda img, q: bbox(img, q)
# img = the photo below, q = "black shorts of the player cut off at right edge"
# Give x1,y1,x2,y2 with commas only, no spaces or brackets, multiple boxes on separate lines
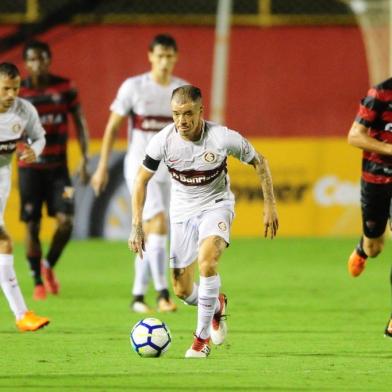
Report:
361,180,392,238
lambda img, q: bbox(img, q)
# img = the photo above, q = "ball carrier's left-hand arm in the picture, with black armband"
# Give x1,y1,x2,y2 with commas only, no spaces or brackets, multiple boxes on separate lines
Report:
128,164,155,258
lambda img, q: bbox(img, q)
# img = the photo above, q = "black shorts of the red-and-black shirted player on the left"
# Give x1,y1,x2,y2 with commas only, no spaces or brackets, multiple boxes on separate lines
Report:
19,166,74,222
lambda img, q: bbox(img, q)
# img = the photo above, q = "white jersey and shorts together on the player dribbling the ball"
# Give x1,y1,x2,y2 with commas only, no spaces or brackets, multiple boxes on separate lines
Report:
143,121,256,268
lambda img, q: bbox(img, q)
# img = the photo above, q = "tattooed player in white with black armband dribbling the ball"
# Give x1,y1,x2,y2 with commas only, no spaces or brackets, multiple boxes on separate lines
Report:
128,85,278,358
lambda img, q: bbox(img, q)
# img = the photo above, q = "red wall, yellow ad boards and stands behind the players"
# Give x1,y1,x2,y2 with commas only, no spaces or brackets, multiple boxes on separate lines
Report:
0,0,370,240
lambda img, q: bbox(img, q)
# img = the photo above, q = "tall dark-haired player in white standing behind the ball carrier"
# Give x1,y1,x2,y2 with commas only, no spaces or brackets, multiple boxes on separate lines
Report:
91,34,185,313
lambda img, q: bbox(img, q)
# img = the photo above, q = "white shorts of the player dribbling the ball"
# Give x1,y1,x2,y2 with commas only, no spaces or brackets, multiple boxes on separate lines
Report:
170,208,234,268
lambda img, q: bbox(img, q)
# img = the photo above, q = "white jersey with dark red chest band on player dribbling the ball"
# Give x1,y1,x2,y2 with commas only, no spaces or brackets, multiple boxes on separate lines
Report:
144,121,256,222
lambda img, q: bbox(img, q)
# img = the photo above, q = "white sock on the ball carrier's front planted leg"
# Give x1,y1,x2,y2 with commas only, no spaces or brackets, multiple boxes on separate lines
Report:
196,275,220,339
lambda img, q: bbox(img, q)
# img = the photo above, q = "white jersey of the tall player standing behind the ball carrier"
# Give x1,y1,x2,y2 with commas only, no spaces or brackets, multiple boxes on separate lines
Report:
110,72,187,182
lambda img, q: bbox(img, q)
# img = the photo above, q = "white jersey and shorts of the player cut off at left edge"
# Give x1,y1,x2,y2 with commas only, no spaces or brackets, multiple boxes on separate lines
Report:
0,98,45,226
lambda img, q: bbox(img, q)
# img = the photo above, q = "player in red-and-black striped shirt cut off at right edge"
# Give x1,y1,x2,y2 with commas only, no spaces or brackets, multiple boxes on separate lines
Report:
348,78,392,337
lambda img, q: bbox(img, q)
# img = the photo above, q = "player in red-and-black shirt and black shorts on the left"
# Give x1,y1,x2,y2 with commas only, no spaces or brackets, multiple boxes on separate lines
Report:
18,41,88,300
